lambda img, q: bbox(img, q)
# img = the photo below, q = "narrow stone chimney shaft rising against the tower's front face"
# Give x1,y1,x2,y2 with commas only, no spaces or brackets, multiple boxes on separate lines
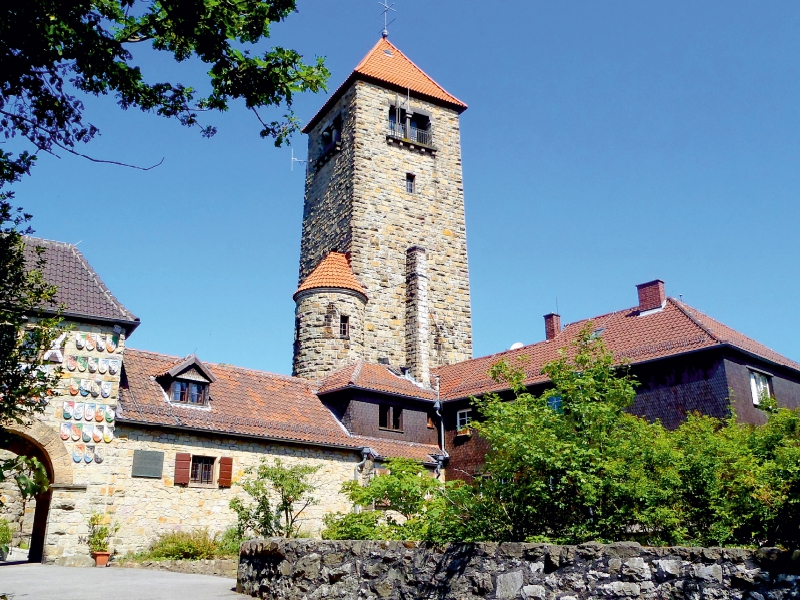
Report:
406,246,431,385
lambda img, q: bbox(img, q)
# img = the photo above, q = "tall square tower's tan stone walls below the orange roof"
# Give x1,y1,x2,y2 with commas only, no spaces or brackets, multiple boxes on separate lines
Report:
300,81,472,378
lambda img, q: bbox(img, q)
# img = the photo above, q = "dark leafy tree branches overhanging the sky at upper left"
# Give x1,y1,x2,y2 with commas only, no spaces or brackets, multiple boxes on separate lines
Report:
0,0,329,186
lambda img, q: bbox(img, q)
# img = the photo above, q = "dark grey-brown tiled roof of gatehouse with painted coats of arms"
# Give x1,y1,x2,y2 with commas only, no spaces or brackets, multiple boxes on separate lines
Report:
24,237,139,334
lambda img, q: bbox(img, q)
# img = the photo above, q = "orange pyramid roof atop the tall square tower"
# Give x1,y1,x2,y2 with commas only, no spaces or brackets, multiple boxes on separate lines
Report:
303,38,467,133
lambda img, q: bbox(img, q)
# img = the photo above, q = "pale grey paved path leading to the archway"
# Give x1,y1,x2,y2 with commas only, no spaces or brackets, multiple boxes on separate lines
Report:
0,564,247,600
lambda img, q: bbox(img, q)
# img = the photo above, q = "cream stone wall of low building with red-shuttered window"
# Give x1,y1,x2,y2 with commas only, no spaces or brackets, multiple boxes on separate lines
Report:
46,424,358,564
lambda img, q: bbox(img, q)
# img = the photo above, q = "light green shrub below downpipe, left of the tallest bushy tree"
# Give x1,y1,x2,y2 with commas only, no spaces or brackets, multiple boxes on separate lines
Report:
322,458,442,540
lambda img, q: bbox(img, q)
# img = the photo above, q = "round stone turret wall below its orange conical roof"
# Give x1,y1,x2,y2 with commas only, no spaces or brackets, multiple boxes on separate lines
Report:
292,290,364,379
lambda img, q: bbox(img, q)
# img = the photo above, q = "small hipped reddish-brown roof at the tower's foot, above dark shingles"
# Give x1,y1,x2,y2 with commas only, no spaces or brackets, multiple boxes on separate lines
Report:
317,360,435,400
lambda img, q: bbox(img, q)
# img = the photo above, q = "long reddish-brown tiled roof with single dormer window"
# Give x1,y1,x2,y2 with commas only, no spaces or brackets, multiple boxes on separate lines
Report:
118,348,439,463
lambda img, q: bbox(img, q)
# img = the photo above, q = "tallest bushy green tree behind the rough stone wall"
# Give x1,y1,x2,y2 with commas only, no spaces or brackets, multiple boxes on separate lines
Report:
432,323,680,543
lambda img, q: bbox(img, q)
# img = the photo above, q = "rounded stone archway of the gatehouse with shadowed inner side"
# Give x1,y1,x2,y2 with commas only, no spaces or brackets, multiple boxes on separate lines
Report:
0,420,73,562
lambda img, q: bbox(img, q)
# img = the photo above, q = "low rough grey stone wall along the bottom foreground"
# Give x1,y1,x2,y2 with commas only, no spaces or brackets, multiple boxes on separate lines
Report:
237,539,800,600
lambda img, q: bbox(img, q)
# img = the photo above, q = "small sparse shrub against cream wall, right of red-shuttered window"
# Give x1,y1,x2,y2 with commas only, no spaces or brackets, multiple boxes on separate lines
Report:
230,458,319,539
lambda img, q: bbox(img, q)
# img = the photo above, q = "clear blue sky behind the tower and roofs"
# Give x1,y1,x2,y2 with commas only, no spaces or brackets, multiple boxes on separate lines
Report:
10,0,800,373
